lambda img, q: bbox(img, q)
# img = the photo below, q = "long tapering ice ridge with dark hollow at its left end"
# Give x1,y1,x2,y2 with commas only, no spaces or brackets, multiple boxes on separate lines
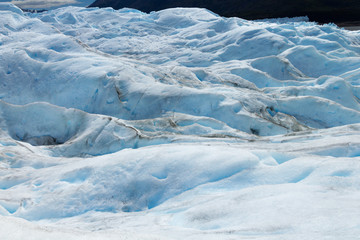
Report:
0,100,254,157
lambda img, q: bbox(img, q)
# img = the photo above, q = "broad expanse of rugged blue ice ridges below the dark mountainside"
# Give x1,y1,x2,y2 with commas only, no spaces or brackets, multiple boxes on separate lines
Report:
3,4,359,135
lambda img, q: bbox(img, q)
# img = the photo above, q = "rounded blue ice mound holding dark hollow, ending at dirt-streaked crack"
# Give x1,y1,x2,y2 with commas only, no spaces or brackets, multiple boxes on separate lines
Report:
0,101,139,157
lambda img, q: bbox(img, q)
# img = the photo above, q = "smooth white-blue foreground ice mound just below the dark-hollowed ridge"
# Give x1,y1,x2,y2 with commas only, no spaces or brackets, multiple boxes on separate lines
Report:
10,143,257,220
